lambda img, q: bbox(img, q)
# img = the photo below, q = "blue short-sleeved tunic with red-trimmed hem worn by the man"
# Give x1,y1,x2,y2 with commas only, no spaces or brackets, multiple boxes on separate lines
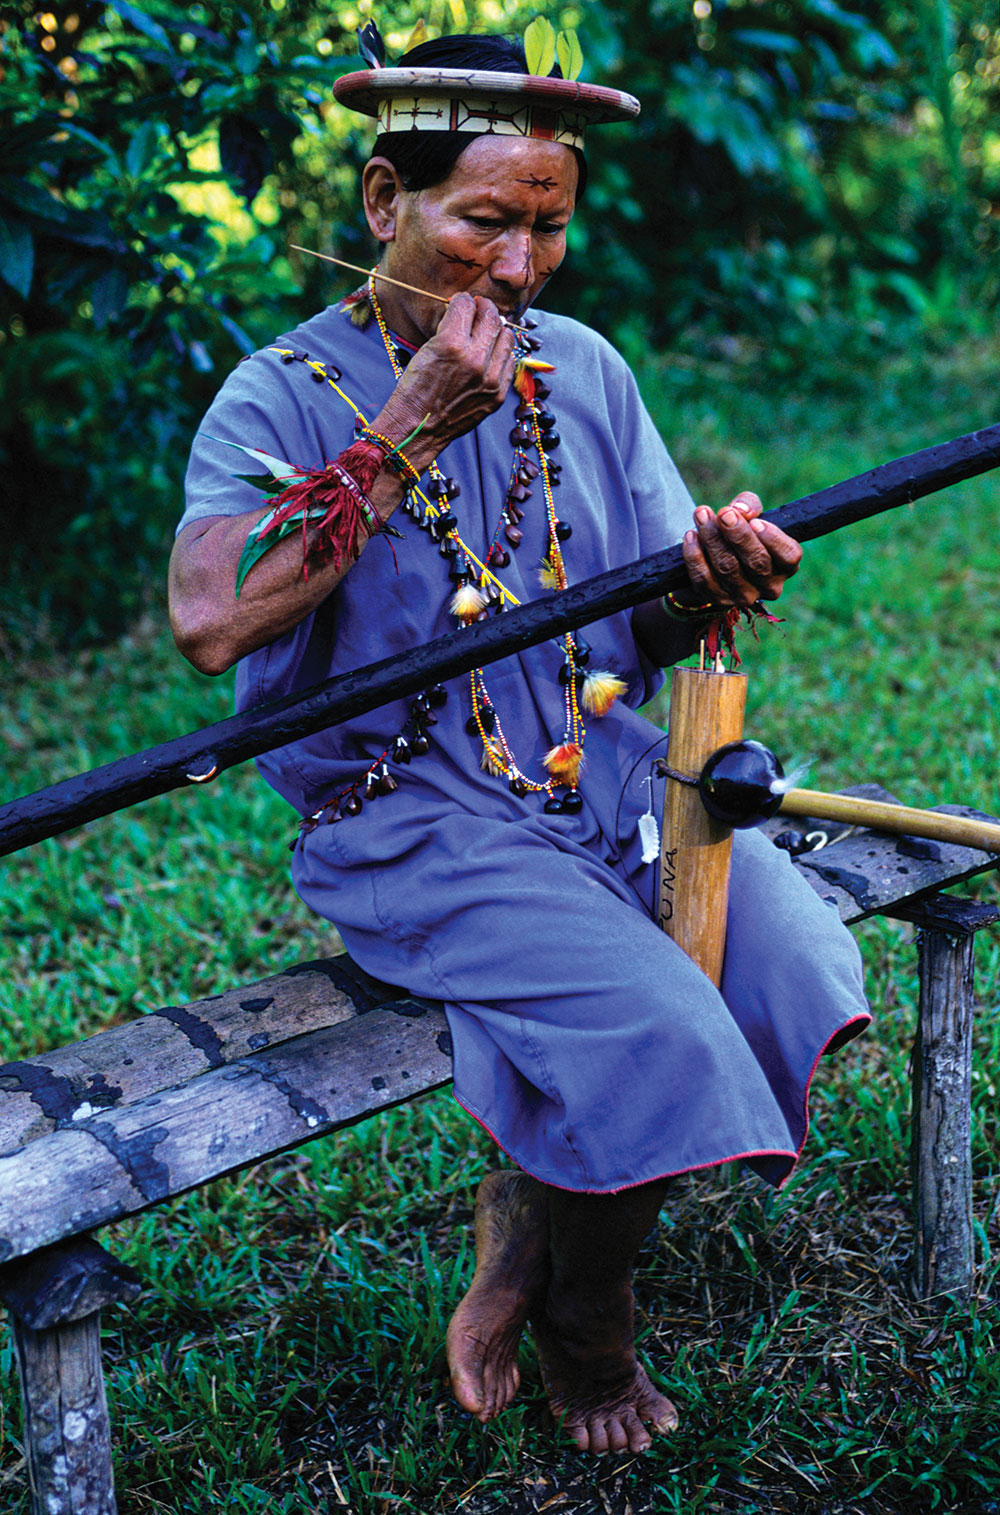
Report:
182,306,868,1192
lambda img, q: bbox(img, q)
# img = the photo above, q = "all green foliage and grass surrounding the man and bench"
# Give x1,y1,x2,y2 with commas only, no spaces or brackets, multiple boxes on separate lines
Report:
0,0,1000,1515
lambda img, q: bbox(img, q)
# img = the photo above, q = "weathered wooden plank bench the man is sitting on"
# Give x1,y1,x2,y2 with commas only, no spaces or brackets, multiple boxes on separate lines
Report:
0,786,1000,1515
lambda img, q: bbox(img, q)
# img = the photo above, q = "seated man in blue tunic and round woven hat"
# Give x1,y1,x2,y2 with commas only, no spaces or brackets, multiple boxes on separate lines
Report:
171,26,868,1453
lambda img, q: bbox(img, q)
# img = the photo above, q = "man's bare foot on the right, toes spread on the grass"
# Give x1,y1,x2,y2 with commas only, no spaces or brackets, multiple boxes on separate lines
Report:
532,1286,677,1453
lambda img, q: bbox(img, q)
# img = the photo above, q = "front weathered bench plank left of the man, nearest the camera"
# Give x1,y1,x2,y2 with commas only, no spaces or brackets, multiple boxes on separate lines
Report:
0,1000,452,1260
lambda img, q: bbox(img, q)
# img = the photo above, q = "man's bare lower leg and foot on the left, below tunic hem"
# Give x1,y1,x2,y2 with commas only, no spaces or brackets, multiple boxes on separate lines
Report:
447,1170,548,1421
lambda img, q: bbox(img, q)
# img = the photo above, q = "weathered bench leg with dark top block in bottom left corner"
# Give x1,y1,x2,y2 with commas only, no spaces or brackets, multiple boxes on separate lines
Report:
0,1236,139,1515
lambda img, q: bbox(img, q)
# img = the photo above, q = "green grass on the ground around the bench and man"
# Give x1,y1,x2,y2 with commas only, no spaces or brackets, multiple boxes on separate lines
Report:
0,337,1000,1515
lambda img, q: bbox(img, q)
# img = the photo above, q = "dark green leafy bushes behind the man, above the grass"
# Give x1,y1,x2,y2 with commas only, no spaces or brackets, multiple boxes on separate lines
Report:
0,0,1000,648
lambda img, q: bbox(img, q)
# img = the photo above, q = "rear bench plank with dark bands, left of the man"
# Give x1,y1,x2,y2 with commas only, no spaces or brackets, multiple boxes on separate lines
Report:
0,954,400,1157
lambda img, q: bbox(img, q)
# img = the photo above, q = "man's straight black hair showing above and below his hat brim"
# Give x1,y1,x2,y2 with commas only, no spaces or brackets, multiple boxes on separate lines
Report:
371,35,586,203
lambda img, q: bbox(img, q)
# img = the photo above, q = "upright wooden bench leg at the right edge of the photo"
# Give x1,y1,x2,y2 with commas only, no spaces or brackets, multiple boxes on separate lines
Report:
911,930,973,1300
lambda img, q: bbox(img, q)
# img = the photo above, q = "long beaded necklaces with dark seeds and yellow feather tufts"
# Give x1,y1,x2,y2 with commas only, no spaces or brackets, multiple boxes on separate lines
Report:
295,278,626,830
